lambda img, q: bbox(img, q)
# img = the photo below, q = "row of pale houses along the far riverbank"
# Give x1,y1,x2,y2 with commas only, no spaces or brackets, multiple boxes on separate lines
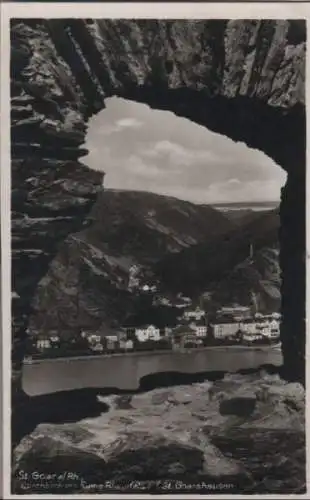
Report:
28,299,280,357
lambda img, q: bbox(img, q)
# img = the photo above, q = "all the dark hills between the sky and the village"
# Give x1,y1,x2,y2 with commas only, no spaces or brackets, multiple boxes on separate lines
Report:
30,190,280,336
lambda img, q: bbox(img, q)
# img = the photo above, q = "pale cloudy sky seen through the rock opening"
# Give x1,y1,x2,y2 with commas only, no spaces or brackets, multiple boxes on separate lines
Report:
82,97,286,204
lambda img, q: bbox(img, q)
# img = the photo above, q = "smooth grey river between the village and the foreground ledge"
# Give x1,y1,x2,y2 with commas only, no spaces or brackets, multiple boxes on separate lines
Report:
22,346,282,396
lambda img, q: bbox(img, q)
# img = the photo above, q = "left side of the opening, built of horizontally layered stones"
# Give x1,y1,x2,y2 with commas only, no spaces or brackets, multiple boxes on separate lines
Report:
11,22,102,372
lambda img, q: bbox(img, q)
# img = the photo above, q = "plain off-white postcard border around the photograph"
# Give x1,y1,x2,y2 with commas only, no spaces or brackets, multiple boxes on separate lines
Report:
0,2,310,500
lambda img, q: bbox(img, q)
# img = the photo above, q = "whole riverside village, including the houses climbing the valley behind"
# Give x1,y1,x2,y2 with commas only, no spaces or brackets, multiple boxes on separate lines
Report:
21,244,281,358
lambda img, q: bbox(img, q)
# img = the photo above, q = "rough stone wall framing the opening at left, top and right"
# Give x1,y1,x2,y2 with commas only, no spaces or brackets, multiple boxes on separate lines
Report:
11,19,305,378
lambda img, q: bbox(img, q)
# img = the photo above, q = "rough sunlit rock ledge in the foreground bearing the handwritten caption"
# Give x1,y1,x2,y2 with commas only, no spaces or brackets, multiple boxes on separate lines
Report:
12,373,305,494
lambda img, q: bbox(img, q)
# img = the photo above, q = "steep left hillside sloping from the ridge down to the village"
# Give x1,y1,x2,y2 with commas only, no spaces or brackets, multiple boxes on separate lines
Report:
30,190,233,336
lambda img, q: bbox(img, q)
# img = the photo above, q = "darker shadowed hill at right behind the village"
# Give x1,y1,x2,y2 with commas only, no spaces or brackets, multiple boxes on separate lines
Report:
156,207,280,300
